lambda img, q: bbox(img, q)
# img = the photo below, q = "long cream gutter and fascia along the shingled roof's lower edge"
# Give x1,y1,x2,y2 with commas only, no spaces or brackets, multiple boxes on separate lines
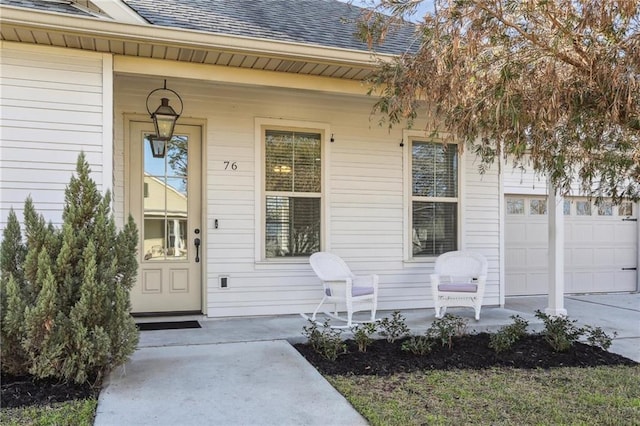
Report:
0,6,394,68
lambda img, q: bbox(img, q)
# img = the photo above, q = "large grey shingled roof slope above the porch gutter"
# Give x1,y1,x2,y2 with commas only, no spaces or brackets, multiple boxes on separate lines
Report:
124,0,413,54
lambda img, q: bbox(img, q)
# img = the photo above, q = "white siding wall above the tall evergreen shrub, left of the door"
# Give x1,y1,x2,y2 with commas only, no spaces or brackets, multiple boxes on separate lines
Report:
0,42,112,225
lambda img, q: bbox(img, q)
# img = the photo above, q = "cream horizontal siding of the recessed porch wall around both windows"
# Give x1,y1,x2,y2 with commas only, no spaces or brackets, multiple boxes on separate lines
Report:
114,76,499,317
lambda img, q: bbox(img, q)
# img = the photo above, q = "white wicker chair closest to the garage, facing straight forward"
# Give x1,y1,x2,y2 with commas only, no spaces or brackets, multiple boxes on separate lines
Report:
431,250,488,321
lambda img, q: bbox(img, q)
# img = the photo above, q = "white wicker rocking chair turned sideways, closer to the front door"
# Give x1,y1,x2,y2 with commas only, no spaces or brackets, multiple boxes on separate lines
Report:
309,252,378,328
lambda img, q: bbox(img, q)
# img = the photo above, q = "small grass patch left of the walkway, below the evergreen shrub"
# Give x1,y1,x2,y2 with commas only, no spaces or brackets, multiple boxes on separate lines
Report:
0,399,98,426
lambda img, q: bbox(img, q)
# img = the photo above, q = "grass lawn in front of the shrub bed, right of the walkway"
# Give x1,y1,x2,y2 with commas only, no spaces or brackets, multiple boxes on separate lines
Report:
326,366,640,425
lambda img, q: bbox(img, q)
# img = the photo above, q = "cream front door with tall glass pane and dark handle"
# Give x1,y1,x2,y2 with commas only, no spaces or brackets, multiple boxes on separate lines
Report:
129,122,204,313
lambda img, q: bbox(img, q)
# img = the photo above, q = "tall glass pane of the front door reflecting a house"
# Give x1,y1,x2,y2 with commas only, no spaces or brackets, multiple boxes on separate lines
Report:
142,136,188,261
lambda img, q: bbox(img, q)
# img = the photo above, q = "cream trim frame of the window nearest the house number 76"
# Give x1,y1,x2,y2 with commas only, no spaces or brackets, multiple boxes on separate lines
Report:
254,118,331,265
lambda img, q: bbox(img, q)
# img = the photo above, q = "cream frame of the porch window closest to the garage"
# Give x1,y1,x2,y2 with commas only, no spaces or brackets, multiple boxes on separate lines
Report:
402,130,464,266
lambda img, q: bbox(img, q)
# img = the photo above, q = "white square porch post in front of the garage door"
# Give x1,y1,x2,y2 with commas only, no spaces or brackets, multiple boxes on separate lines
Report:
545,183,567,316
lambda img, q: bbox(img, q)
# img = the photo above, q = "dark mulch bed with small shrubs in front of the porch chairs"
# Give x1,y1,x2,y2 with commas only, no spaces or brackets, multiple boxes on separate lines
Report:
294,333,638,376
